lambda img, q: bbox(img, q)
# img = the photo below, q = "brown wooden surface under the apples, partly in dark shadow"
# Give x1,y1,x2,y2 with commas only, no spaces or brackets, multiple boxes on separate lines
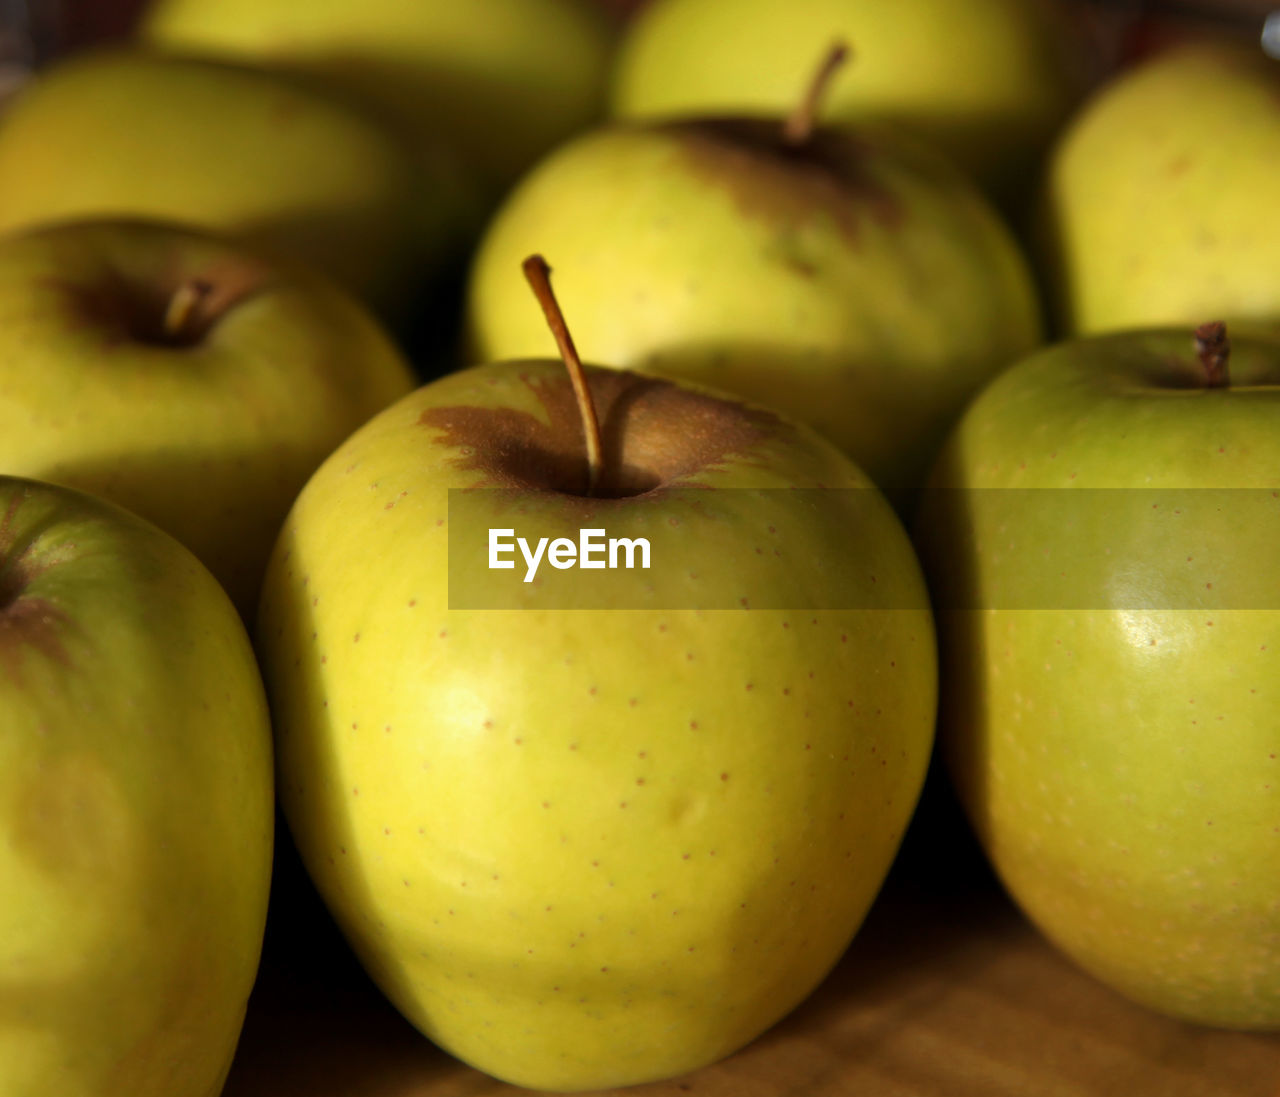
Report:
224,805,1280,1097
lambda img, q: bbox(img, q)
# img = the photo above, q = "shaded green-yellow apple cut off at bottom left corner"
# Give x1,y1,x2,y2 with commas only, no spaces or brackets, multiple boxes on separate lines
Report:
0,476,274,1097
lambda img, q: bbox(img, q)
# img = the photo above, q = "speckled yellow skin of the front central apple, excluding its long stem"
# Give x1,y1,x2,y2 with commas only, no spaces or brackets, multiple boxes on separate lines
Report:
257,361,936,1091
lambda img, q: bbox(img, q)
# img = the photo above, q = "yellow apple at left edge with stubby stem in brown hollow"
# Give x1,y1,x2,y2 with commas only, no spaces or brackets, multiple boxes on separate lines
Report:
0,221,415,612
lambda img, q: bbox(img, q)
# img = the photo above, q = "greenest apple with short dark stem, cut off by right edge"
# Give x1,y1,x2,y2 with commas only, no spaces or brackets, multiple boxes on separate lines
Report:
919,321,1280,1029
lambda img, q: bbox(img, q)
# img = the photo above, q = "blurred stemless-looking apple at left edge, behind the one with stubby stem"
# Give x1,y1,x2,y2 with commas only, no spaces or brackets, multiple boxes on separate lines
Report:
0,49,461,312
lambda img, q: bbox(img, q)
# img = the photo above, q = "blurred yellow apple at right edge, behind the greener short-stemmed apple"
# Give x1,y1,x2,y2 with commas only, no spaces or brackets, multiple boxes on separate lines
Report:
1038,42,1280,334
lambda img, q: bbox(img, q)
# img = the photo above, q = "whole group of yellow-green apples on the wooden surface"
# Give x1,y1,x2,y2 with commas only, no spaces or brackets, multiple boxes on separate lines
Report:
0,0,1280,1097
